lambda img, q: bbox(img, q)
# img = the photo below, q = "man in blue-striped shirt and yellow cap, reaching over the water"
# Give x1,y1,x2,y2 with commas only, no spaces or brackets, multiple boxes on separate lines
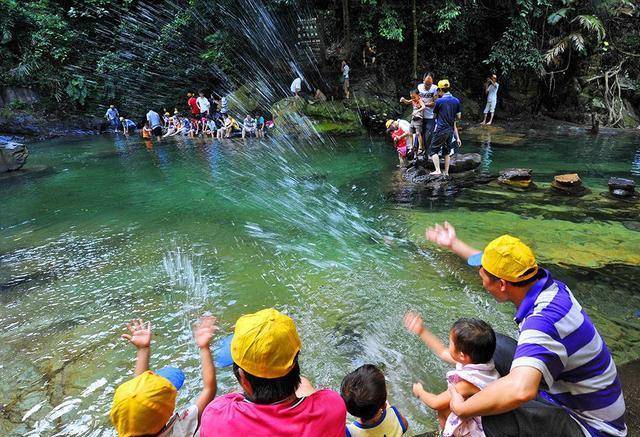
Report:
426,222,627,437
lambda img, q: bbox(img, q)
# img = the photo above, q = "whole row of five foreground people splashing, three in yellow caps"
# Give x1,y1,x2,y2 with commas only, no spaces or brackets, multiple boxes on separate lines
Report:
110,222,626,437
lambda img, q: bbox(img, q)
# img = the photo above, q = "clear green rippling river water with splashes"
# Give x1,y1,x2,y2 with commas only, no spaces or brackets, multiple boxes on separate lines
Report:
0,131,640,435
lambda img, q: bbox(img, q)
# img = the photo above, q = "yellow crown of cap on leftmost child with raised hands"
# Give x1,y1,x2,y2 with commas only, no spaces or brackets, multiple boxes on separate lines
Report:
109,370,178,437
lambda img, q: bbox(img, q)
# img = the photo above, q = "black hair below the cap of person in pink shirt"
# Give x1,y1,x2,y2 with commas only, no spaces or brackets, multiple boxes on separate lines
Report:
233,355,301,404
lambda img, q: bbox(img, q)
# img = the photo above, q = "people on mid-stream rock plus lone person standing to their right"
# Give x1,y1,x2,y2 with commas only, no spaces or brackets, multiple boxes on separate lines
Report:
386,72,500,176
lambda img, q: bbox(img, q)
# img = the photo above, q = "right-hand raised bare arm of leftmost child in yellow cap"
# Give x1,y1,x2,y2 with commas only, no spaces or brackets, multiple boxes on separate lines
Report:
193,316,218,420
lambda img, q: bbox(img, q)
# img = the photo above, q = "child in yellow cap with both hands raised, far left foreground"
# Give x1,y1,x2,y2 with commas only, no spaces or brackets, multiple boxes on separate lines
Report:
110,316,218,437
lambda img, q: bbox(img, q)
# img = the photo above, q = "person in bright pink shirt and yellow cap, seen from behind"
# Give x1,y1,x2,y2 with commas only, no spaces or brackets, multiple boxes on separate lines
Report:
200,308,347,437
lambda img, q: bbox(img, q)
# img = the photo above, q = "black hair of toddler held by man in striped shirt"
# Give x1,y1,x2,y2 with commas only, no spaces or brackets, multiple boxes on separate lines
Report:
451,318,496,364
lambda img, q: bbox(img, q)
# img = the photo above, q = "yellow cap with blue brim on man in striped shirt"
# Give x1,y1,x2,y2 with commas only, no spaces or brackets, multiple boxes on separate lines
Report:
467,235,538,282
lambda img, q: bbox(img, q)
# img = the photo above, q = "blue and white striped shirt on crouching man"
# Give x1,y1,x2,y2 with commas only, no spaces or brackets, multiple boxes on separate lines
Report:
511,270,627,437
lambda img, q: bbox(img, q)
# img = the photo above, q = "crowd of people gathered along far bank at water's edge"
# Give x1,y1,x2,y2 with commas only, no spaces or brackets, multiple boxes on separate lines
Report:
105,91,273,140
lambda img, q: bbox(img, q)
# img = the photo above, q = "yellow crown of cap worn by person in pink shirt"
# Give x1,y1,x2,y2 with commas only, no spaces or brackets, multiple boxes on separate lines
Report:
231,308,302,379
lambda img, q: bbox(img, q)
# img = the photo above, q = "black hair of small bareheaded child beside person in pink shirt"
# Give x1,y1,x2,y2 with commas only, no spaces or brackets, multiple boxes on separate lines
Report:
340,364,387,421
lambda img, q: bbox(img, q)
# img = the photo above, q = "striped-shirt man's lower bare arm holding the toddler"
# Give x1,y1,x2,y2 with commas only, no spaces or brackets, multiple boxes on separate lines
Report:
449,366,542,419
